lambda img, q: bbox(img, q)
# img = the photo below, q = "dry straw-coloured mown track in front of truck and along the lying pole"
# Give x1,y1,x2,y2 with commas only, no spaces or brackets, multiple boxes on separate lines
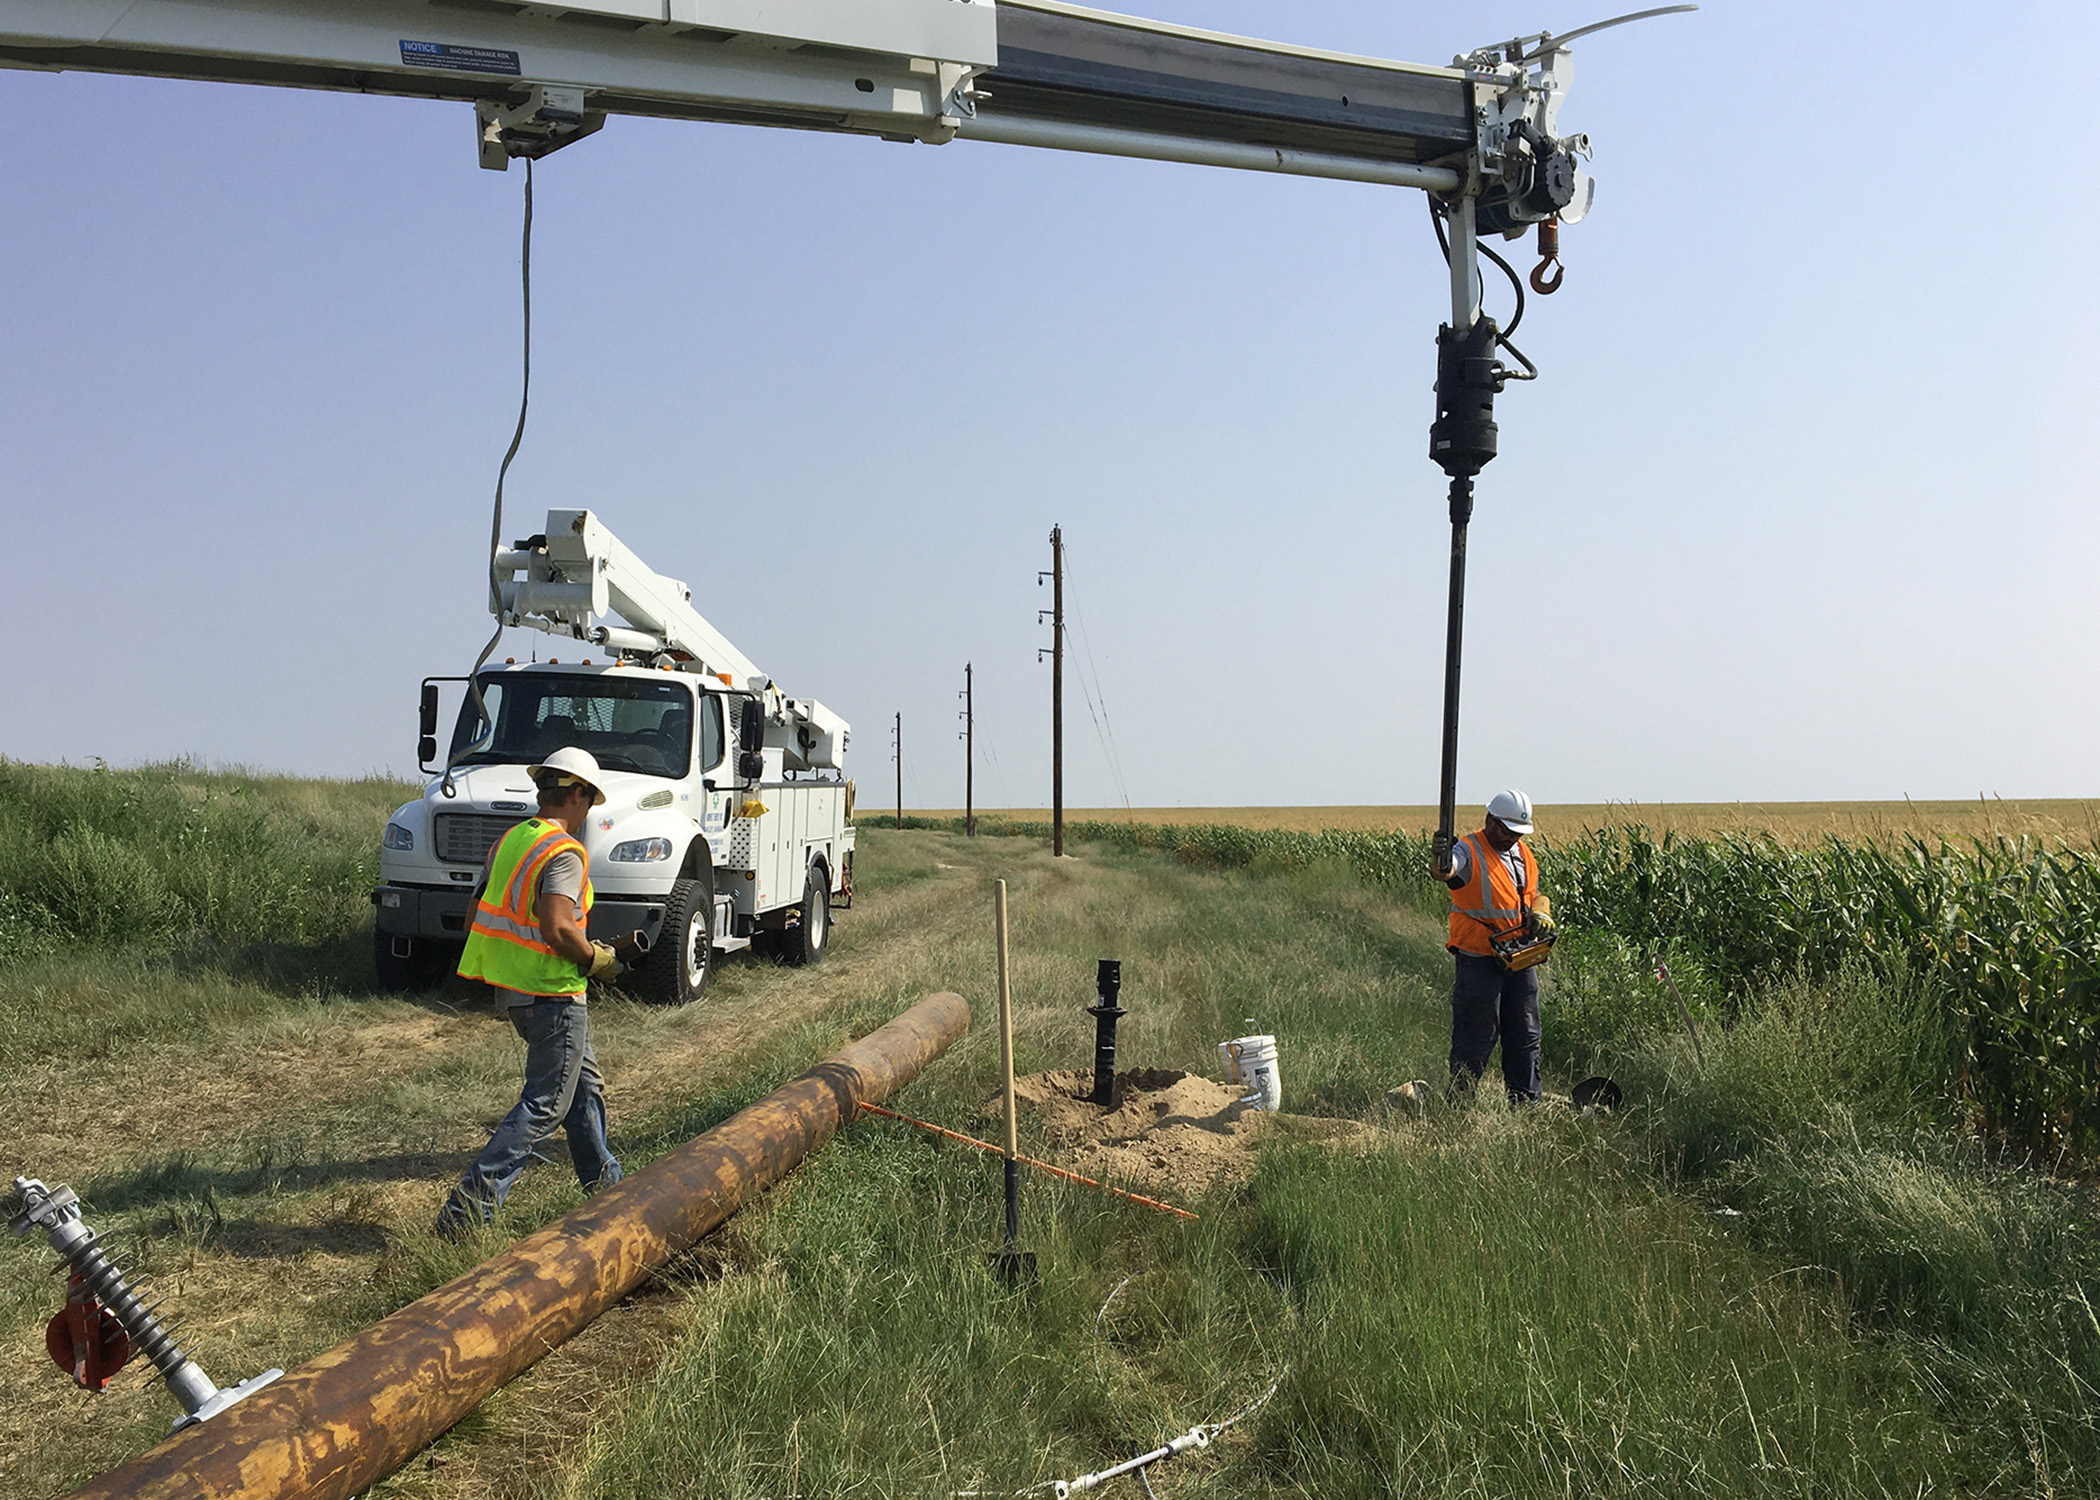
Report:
0,840,1019,1496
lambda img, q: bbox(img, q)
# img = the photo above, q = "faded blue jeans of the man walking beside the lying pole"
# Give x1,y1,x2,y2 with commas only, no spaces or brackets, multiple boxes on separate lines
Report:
437,1000,620,1229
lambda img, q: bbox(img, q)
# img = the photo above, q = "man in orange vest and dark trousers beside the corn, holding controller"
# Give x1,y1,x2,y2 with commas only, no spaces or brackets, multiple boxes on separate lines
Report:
1436,788,1541,1105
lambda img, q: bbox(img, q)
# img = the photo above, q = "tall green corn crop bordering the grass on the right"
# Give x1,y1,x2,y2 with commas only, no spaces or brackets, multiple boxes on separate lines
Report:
907,819,2100,1153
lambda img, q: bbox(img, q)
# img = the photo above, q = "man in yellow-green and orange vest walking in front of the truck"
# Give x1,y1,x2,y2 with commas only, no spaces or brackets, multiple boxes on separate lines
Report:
437,748,620,1235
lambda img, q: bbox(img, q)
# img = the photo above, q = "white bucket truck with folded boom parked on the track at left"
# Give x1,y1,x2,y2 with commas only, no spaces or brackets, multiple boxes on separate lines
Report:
372,511,853,1002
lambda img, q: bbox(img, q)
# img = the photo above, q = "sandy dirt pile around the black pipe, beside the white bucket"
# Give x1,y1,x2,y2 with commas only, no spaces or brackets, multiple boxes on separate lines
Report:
983,1067,1363,1197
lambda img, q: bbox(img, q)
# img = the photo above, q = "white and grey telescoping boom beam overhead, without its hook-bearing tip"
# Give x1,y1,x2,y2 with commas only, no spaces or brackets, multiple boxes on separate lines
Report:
0,0,1474,191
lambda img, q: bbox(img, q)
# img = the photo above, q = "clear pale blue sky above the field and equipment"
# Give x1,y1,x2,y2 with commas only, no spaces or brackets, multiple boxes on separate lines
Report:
0,0,2100,805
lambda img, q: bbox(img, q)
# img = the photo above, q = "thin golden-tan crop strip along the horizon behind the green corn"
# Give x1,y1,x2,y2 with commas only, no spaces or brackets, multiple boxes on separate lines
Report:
902,798,2100,847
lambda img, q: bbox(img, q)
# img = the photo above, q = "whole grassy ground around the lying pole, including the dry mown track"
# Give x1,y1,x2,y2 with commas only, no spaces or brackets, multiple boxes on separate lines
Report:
0,767,2100,1500
